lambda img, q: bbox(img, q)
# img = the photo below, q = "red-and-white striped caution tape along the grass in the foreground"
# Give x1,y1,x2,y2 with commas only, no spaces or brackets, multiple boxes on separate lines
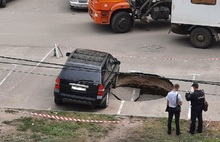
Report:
19,112,121,124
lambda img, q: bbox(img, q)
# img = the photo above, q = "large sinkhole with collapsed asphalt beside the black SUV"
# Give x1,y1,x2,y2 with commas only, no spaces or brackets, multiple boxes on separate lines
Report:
111,72,173,102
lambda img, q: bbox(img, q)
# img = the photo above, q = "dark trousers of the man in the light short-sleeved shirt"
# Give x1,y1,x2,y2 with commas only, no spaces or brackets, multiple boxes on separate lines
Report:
168,107,180,134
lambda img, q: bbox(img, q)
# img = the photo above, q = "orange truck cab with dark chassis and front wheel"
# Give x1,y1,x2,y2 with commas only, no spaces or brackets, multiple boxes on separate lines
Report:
88,0,171,33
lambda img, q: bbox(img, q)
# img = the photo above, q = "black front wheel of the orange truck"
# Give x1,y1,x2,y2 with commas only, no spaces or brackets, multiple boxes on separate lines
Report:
111,11,132,33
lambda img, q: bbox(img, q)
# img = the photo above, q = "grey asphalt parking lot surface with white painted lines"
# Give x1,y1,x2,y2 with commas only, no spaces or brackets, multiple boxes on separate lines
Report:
0,0,220,120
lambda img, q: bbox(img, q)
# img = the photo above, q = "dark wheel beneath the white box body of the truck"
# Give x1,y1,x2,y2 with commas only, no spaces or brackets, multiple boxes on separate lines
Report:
190,27,213,49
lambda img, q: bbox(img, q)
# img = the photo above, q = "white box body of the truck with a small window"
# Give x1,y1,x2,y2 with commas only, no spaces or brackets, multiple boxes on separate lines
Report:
171,0,220,27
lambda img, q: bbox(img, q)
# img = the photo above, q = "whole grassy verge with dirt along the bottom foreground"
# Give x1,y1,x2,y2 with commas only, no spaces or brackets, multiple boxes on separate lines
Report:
3,112,220,142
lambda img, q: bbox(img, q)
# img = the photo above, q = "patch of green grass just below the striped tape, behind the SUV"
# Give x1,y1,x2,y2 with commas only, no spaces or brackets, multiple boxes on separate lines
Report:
4,117,113,141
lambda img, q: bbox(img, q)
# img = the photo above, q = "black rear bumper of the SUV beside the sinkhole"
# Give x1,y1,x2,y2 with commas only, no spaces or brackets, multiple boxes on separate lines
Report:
54,92,103,106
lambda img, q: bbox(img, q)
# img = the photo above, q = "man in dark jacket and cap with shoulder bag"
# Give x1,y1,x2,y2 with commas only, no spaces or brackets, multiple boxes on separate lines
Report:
185,82,205,134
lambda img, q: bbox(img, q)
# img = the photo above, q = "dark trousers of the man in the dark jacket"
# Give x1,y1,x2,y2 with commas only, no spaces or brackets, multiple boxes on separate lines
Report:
189,106,203,134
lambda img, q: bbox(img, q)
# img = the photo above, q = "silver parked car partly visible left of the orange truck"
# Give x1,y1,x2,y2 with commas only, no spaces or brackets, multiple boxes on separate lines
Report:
70,0,89,9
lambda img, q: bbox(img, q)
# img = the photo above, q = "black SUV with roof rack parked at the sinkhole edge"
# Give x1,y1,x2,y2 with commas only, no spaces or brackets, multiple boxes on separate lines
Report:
54,49,120,108
